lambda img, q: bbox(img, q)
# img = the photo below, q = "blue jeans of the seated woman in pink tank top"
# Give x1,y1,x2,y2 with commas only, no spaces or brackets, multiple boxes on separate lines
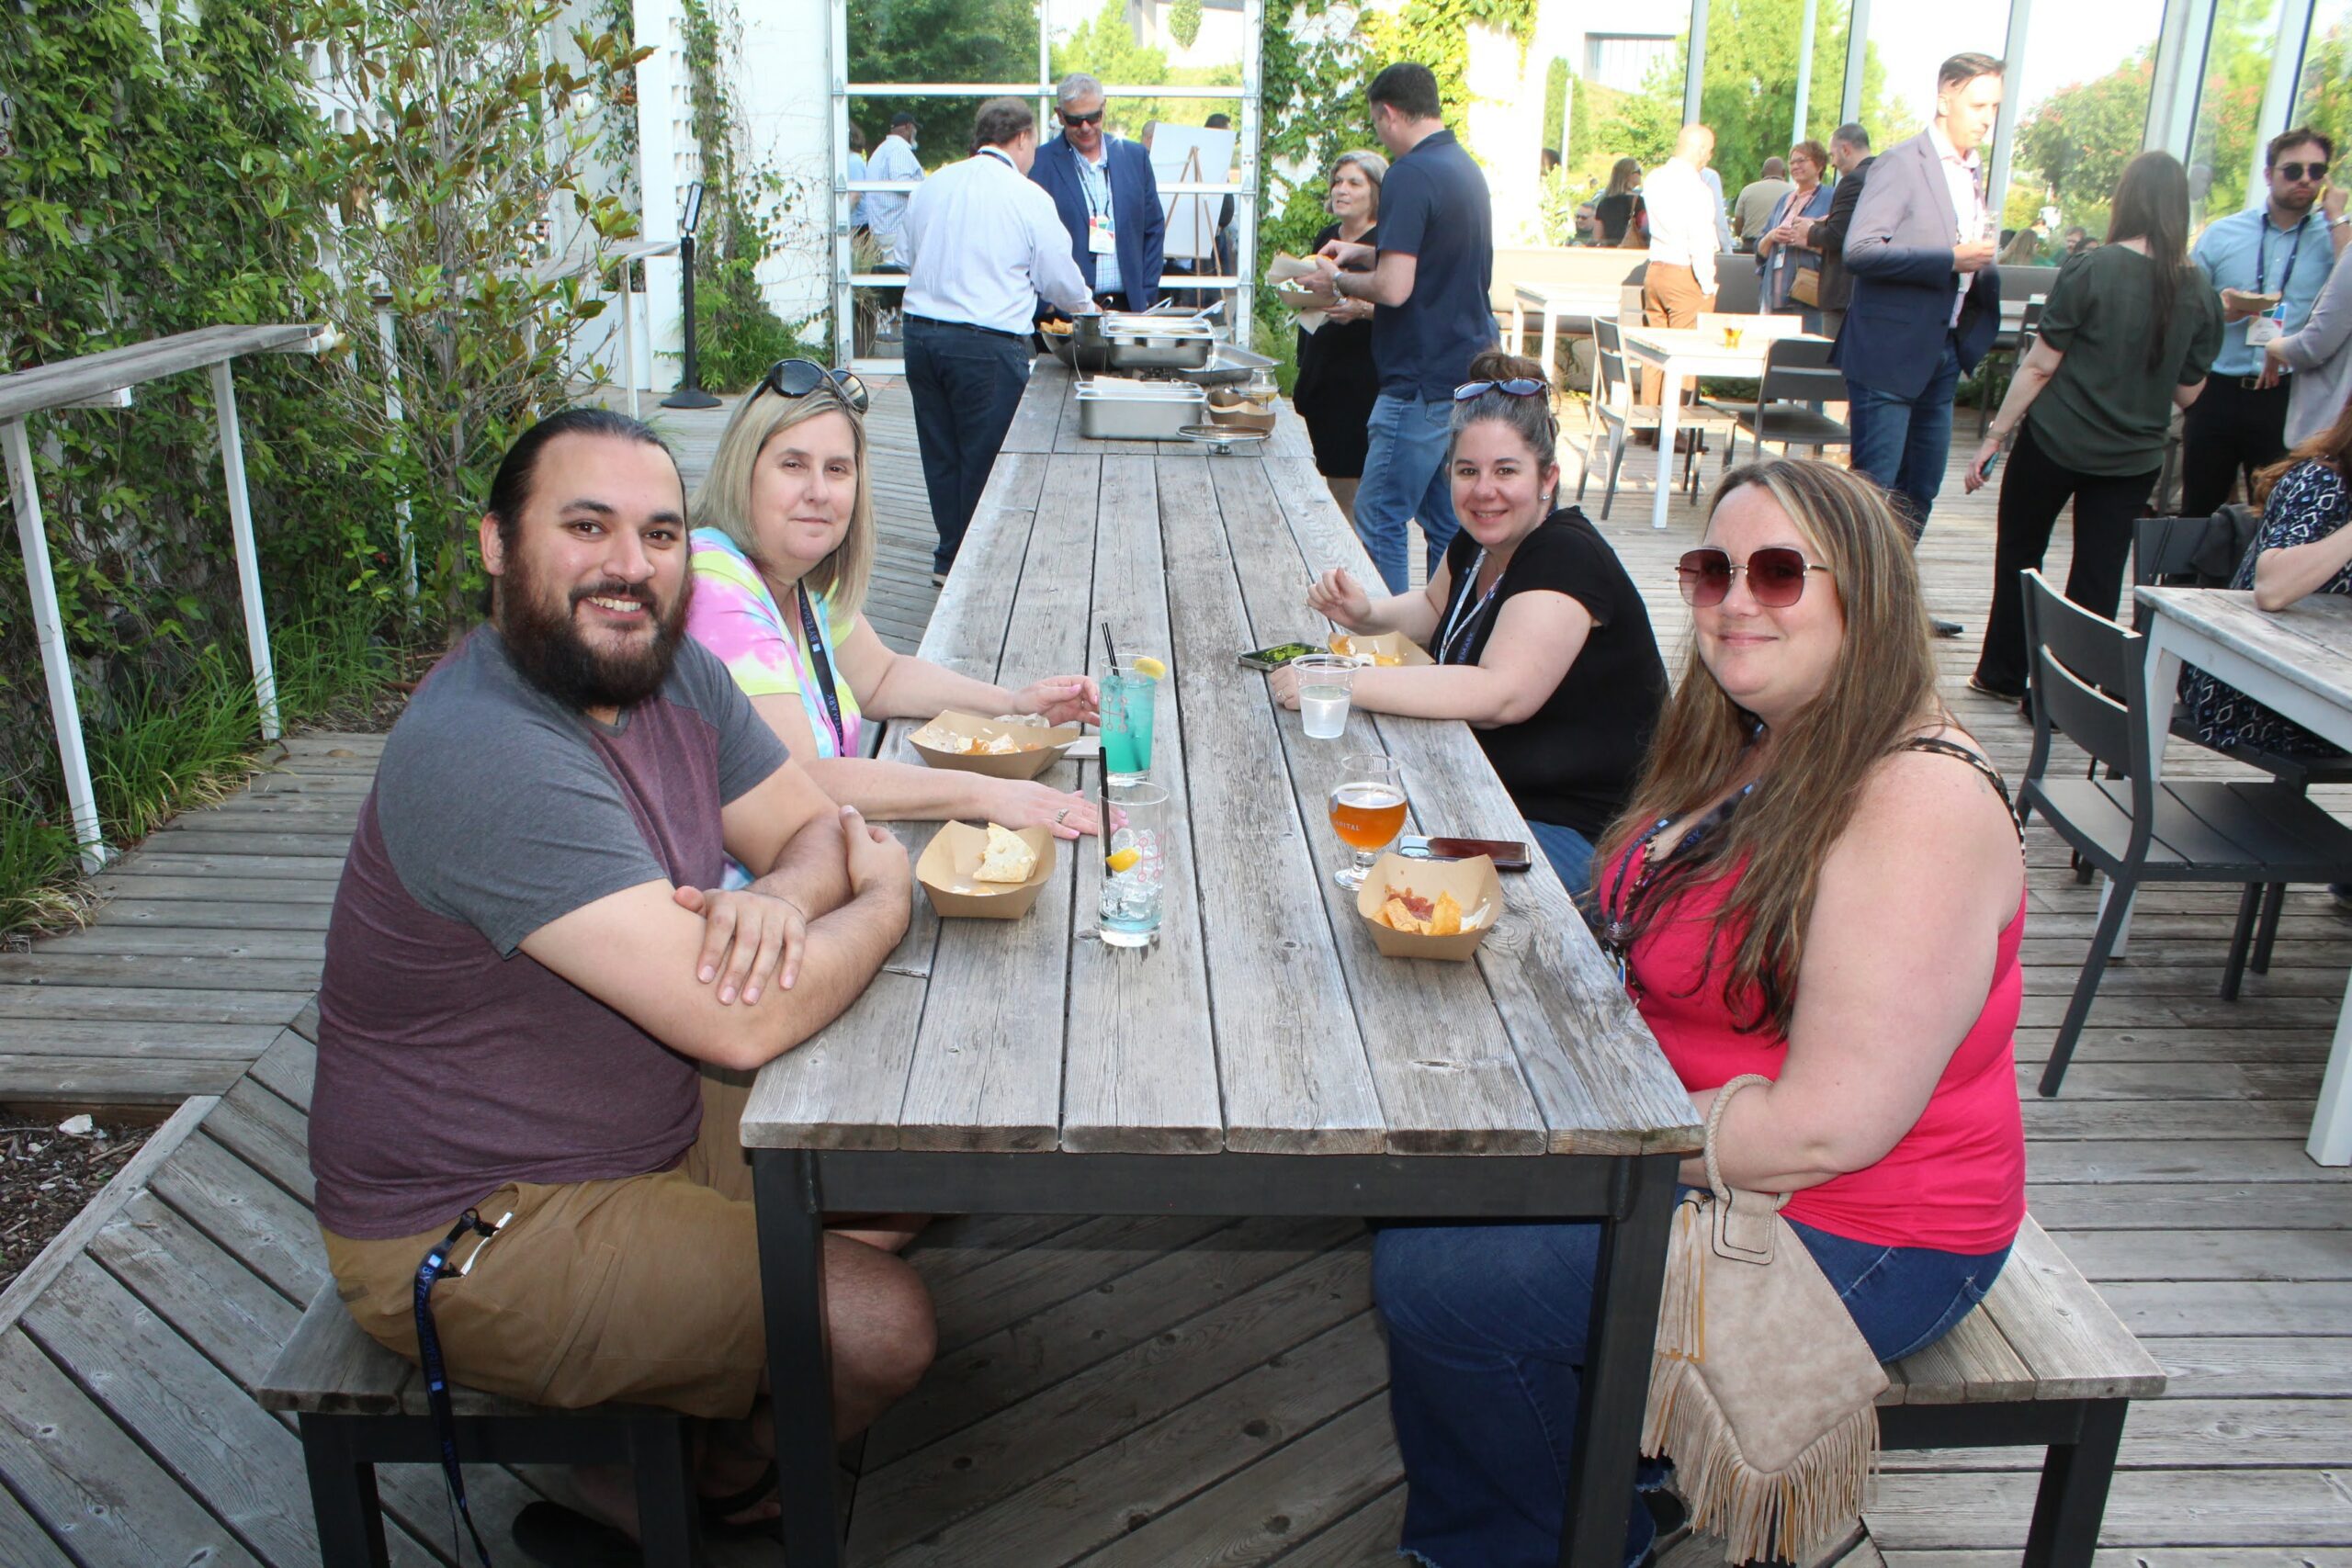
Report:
1371,1223,2008,1568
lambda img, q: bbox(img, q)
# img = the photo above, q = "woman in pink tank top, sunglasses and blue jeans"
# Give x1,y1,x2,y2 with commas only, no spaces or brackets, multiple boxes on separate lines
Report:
1374,461,2025,1568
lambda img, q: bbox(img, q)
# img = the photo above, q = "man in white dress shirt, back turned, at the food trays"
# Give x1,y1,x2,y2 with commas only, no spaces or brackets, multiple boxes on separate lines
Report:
885,98,1096,583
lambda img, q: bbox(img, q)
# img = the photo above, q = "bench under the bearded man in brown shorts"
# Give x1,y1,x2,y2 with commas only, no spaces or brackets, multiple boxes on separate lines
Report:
254,1281,701,1568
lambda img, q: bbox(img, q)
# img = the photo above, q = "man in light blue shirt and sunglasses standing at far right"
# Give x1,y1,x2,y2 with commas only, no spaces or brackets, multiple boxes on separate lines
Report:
2180,127,2352,517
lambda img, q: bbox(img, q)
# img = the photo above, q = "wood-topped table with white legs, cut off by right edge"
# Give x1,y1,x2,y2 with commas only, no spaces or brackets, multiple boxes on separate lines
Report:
2138,588,2352,1166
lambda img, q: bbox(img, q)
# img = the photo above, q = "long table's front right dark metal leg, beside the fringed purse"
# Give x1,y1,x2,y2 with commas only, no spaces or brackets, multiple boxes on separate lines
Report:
1559,1155,1679,1568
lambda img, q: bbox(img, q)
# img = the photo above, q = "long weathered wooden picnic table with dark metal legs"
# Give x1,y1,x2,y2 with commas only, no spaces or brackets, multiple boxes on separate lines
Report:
743,362,1701,1568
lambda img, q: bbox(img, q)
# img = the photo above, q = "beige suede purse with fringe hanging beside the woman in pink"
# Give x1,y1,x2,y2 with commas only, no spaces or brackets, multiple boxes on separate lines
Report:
1642,1072,1886,1561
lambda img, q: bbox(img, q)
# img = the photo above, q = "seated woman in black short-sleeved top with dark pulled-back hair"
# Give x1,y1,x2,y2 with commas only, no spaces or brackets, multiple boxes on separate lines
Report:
1270,350,1665,900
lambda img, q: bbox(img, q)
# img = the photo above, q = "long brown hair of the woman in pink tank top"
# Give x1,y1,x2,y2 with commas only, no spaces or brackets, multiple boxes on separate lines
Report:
1595,458,1943,1037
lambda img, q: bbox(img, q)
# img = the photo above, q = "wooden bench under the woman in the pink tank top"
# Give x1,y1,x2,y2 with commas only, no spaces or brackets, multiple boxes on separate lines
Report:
1879,1215,2164,1568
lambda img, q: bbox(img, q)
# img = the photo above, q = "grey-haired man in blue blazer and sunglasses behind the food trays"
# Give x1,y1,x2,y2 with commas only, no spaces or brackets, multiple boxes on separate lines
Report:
1030,73,1167,310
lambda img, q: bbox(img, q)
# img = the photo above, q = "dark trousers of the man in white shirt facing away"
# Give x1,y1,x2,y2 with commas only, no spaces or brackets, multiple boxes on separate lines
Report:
906,315,1035,571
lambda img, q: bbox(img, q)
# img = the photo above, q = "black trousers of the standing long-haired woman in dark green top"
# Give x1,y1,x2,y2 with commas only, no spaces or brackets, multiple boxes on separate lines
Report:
1975,423,2157,691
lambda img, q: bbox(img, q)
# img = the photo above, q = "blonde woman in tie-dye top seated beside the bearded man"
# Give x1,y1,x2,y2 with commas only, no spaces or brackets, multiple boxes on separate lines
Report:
687,360,1096,879
